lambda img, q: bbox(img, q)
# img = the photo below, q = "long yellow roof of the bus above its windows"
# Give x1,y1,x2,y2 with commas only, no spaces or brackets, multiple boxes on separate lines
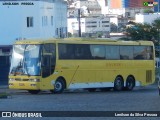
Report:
15,38,153,45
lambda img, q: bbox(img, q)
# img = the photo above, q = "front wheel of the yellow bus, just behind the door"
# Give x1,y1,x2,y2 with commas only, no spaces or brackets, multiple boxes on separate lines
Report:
53,79,65,93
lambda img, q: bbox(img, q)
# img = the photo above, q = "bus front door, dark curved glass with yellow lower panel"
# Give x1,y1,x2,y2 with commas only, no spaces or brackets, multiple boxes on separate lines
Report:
41,44,56,89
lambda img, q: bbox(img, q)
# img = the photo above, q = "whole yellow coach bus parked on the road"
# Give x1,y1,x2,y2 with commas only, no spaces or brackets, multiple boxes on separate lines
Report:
9,38,155,94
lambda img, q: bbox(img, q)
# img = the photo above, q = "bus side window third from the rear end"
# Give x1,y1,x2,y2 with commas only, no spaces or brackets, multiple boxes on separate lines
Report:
106,46,119,60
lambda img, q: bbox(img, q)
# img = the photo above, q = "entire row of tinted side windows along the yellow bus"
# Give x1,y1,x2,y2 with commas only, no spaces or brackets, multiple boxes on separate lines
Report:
58,44,153,60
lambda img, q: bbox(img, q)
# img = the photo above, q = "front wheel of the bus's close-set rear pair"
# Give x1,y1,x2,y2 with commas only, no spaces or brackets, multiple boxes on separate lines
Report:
114,76,124,91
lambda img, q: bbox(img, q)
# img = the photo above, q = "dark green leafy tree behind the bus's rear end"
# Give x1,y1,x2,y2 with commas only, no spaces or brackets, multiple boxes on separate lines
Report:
126,18,160,56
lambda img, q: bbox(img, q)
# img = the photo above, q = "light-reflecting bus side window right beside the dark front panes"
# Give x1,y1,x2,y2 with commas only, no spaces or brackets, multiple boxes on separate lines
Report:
90,45,105,59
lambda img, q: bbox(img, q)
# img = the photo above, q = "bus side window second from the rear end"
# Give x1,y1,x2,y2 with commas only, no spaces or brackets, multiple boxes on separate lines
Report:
120,46,133,60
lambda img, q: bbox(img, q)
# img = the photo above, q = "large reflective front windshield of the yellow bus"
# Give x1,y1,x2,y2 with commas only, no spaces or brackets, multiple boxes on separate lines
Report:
10,44,40,76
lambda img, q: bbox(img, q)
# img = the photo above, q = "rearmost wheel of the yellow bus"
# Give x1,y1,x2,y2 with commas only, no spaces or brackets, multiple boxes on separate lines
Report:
126,76,135,91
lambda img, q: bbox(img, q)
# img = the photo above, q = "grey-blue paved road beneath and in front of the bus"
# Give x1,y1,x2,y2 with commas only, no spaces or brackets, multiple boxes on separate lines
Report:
0,85,160,120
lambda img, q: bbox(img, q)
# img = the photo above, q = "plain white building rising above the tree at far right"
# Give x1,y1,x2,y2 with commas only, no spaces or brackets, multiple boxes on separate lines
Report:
135,13,160,24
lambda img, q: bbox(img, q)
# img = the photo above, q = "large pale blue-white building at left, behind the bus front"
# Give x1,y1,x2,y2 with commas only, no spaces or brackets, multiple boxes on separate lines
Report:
0,0,67,45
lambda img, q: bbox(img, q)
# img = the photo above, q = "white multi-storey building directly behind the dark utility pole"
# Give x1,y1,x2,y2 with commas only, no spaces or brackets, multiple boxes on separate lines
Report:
68,17,110,36
